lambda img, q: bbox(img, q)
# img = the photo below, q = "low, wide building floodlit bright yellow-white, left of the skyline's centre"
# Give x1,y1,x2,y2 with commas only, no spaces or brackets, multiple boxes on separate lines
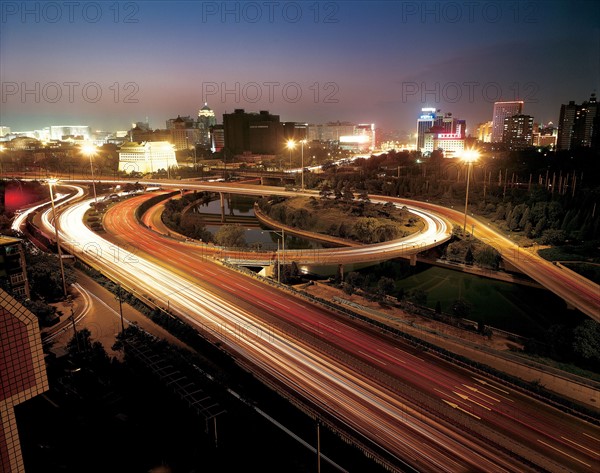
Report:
119,141,177,174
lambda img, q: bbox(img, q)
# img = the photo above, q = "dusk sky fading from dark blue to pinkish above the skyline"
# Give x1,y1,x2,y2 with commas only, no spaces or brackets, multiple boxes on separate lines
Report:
0,0,600,133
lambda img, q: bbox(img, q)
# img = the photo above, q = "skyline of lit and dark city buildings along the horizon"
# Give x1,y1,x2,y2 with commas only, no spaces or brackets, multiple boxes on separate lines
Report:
0,94,600,173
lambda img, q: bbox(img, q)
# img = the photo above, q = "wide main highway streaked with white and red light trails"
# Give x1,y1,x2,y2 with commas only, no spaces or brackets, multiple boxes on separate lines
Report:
52,190,600,471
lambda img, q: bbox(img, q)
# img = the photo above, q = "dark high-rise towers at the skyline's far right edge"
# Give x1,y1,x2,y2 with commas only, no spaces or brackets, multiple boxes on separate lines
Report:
556,94,600,150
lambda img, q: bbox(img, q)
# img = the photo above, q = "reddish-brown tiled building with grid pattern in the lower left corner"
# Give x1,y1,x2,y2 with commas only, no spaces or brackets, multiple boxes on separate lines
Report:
0,289,48,473
